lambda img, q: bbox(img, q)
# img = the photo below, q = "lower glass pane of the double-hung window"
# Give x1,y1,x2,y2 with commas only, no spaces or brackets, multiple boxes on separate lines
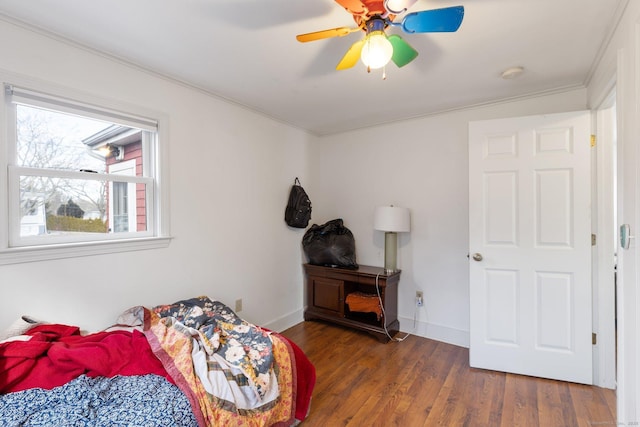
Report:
20,176,147,237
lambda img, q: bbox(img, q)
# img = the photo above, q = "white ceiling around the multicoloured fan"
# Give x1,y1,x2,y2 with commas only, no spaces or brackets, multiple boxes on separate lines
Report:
0,0,628,135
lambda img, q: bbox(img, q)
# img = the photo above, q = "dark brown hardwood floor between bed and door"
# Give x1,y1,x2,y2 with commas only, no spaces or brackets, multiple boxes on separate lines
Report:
283,321,616,427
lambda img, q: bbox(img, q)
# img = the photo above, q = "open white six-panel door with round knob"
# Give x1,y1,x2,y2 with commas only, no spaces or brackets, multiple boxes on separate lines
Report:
469,112,592,384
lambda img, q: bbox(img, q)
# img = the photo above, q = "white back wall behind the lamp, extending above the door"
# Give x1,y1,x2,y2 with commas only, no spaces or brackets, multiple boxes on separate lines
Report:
309,89,586,346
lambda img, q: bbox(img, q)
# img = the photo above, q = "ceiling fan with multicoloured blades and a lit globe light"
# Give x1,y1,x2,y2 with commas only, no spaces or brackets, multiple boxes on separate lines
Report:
296,0,464,71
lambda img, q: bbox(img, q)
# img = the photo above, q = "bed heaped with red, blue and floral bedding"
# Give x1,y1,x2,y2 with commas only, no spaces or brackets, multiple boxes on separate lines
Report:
0,296,315,427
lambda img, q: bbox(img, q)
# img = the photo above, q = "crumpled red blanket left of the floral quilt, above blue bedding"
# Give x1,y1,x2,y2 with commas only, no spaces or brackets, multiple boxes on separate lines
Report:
0,325,173,393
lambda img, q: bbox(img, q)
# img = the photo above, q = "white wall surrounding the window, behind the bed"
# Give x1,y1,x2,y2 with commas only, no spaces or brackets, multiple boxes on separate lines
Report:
0,21,313,330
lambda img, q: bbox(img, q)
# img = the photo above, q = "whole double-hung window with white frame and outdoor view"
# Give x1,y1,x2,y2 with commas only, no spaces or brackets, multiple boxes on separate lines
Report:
0,83,167,264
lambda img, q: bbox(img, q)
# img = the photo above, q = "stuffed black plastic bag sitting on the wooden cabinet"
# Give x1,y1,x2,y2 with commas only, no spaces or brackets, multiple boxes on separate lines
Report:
302,219,358,269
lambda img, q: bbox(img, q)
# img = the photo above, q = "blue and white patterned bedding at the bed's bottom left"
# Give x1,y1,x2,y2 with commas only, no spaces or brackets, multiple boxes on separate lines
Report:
0,375,198,427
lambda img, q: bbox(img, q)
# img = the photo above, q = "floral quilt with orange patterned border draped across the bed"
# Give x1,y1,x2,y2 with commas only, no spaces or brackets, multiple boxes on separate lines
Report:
131,297,297,427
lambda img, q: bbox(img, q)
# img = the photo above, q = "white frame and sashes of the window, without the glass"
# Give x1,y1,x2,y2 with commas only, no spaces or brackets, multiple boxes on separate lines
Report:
0,72,171,265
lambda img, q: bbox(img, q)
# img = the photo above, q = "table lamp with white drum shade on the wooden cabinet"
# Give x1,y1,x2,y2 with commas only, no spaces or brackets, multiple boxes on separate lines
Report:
373,205,411,274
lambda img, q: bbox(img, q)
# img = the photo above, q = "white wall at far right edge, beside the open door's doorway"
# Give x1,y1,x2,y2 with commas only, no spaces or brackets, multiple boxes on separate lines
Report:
588,0,640,425
